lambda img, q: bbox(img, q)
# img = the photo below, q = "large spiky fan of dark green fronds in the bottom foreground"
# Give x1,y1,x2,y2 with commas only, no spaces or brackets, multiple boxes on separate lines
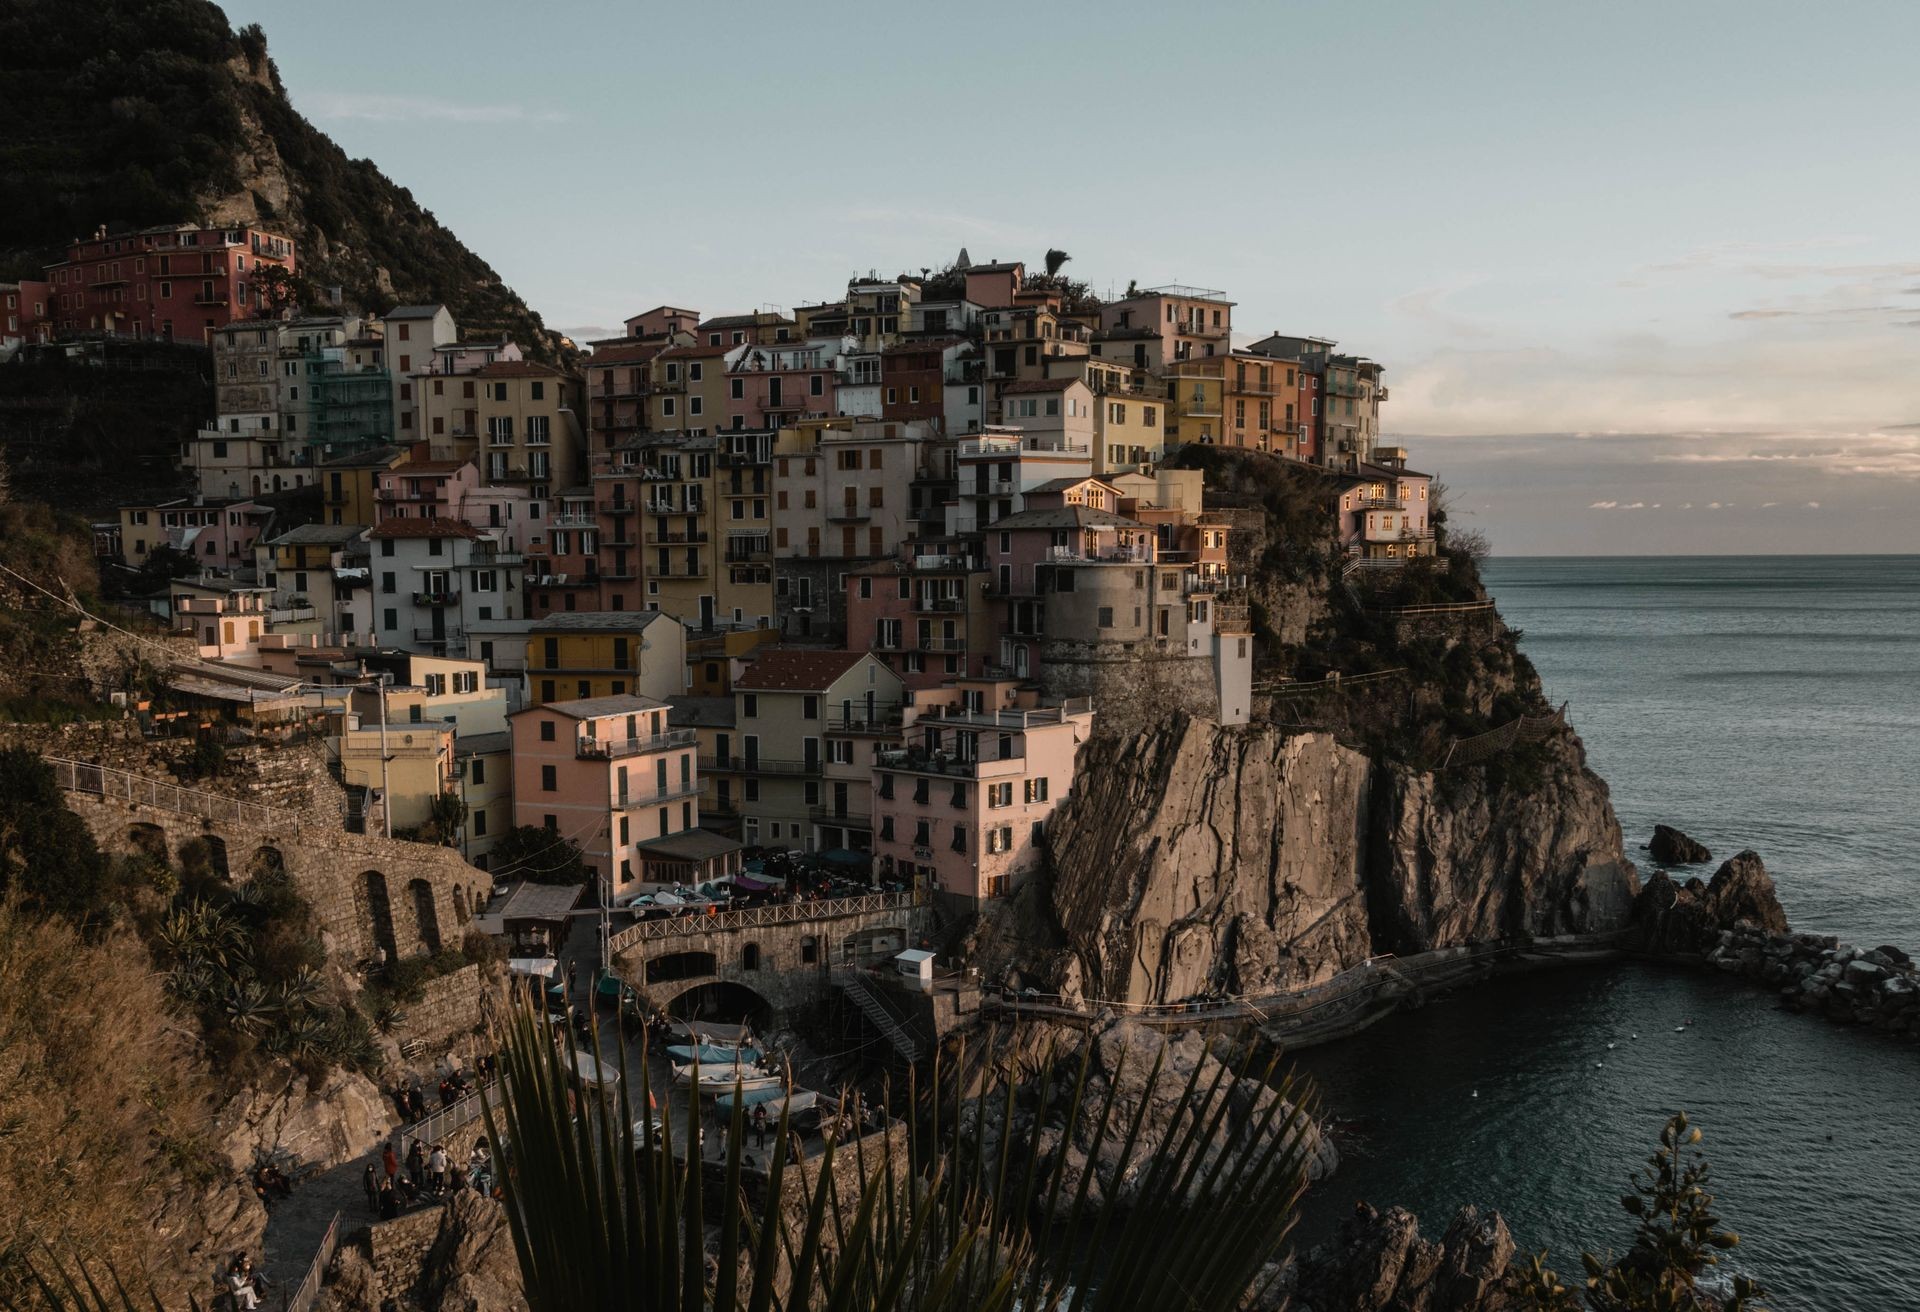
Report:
484,1001,1308,1312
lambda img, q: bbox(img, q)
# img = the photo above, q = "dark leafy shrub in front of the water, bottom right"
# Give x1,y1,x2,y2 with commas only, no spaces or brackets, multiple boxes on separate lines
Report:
1517,1112,1766,1312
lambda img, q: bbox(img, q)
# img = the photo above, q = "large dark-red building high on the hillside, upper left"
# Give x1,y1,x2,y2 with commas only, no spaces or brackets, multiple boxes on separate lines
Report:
46,225,294,342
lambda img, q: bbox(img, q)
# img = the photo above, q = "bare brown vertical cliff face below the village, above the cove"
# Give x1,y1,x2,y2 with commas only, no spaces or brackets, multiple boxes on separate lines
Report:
1050,715,1638,1003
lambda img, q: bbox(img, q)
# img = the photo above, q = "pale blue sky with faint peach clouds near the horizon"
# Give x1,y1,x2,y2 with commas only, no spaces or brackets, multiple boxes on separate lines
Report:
225,0,1920,555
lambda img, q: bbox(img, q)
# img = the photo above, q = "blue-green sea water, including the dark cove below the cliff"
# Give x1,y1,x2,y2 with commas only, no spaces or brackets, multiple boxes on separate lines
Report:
1296,555,1920,1312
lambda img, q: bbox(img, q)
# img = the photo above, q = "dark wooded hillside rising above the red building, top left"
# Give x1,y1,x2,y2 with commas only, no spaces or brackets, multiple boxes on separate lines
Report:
0,0,559,359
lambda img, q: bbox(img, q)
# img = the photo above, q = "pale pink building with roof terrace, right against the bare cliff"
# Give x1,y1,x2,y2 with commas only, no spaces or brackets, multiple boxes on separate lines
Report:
874,680,1092,903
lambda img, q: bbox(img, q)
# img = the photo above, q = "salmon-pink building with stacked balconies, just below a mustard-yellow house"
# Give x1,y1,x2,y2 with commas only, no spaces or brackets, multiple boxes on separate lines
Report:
509,695,718,901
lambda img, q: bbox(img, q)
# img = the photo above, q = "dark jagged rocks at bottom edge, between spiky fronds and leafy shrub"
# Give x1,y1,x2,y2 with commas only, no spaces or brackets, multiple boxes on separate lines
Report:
1265,1203,1519,1312
